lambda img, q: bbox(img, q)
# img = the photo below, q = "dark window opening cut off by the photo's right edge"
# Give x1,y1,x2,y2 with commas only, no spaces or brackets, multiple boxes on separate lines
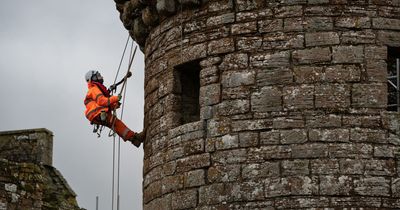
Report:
387,47,400,111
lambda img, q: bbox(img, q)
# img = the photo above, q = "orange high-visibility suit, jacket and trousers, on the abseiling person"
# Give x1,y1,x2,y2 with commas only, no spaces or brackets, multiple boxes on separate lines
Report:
84,81,135,141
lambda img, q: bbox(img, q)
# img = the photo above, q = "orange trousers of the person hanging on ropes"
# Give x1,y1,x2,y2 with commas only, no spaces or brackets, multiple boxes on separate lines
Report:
93,112,135,141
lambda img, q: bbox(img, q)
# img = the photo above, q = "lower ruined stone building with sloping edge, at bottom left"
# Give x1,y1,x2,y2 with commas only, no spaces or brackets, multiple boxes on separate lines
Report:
0,129,83,210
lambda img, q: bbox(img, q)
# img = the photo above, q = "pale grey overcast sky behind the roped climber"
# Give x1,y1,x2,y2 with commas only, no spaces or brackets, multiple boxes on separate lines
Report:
0,0,144,210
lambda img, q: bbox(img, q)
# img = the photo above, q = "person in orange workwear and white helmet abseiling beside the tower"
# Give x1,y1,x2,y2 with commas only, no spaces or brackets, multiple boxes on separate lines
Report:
84,70,144,147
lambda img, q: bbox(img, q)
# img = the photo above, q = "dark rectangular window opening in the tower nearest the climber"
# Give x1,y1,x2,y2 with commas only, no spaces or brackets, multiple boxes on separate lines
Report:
175,61,201,125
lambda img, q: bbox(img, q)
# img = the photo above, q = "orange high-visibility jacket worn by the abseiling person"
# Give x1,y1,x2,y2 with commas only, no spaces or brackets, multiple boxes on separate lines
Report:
84,82,118,122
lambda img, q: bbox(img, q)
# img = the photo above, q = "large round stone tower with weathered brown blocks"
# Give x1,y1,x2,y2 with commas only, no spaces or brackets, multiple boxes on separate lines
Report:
115,0,400,210
